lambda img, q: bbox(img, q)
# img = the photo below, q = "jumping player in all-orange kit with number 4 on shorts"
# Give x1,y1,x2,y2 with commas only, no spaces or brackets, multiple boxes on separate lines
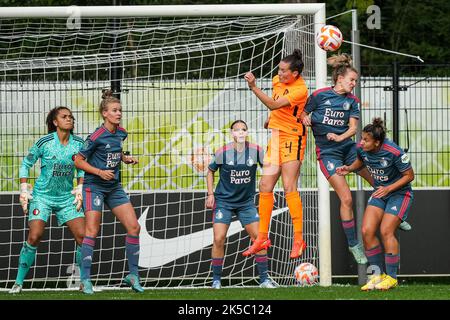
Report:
243,49,308,259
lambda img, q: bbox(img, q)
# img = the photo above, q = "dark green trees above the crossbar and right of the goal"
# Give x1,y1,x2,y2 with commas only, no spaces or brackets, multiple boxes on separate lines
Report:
0,0,450,76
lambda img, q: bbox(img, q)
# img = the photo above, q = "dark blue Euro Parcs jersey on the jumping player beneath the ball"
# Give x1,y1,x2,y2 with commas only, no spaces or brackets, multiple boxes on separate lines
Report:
305,87,359,140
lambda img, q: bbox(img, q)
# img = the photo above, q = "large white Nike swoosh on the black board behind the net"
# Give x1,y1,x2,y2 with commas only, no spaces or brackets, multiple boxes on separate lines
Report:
138,207,289,268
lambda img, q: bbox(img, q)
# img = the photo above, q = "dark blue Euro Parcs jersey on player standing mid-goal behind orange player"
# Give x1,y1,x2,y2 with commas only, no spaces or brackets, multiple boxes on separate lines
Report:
209,142,264,208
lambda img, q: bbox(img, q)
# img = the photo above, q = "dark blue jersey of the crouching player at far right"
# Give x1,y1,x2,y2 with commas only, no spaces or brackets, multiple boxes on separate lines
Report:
356,139,411,191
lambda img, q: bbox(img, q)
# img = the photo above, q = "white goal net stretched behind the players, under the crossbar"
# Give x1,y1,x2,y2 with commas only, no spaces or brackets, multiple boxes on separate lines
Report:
0,7,326,289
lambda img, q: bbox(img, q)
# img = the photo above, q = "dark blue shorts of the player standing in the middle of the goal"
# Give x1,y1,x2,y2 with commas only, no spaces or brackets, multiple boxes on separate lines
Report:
213,202,259,227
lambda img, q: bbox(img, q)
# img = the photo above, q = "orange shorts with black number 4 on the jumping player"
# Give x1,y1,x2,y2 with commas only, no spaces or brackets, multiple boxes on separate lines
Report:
264,129,306,166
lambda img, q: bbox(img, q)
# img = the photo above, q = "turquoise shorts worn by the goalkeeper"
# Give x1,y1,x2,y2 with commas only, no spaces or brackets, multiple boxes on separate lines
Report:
28,196,84,226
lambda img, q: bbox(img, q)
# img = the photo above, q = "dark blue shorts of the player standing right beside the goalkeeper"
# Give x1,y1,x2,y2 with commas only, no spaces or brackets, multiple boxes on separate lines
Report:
83,184,130,212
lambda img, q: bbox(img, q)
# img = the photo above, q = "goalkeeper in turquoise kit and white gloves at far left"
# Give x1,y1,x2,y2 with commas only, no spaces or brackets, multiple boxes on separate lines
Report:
10,107,85,293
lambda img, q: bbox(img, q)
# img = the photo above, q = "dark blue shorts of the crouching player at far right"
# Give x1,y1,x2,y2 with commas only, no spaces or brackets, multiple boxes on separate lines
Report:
367,190,414,221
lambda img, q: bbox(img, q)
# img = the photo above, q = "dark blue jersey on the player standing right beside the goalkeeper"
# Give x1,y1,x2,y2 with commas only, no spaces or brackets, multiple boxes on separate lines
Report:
79,125,128,187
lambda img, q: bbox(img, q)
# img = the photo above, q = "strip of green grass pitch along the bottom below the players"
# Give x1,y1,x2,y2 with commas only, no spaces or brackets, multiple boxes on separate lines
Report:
0,283,450,300
